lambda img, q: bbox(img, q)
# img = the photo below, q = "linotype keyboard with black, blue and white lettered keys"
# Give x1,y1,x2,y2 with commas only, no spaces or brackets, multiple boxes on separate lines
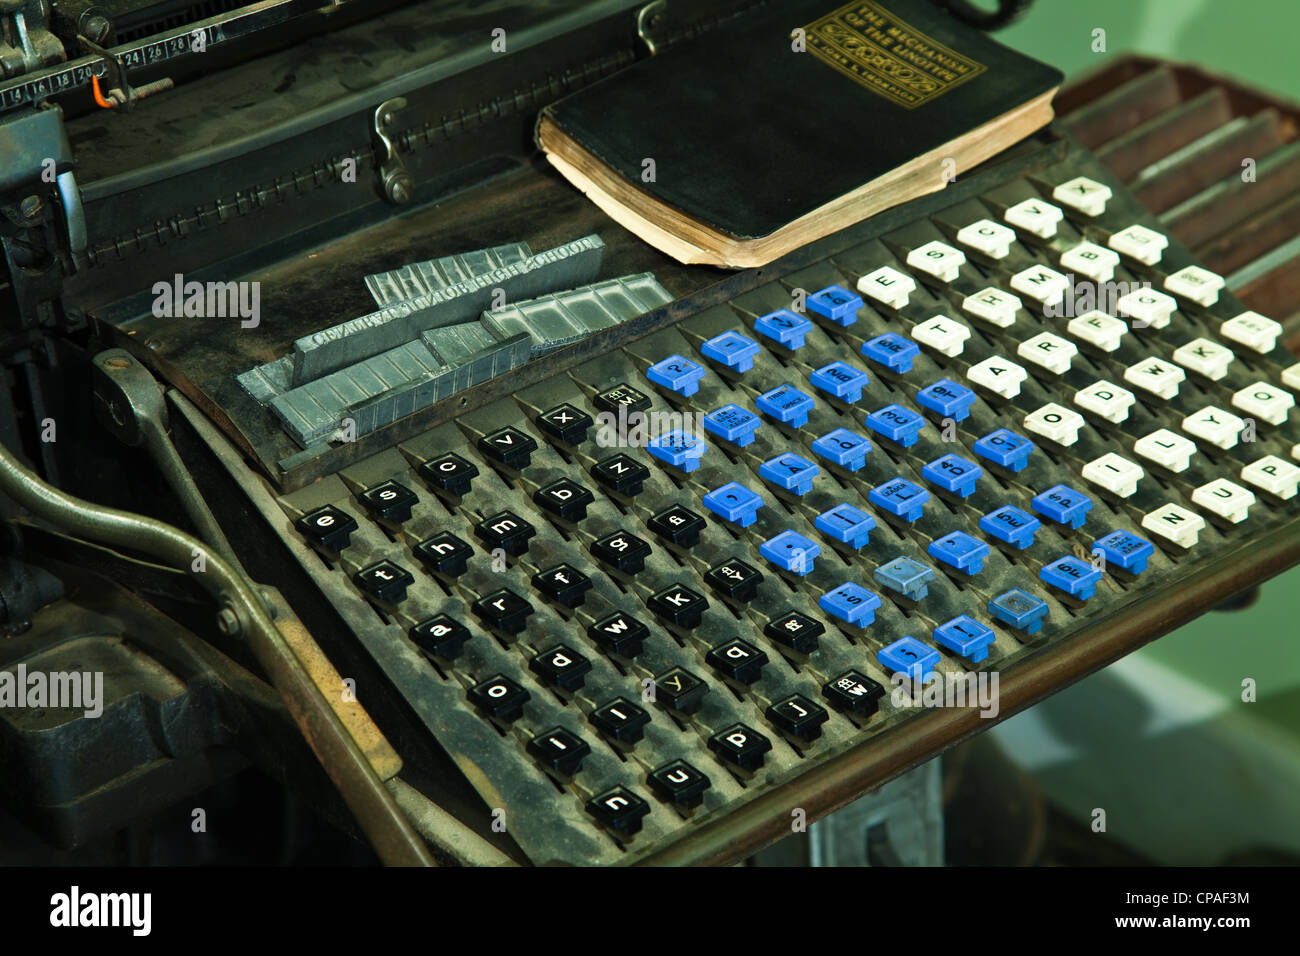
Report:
263,136,1300,864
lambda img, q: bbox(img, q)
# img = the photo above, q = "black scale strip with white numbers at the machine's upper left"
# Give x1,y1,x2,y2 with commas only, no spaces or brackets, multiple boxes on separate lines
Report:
0,0,328,112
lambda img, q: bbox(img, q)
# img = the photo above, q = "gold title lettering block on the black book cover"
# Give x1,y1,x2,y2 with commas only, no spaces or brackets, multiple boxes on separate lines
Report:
805,0,984,109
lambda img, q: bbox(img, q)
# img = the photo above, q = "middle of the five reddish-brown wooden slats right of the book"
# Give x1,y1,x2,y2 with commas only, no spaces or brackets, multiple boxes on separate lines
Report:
1132,109,1284,215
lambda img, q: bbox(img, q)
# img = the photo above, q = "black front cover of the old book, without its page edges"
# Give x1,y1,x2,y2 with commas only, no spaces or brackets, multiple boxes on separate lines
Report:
542,0,1062,239
